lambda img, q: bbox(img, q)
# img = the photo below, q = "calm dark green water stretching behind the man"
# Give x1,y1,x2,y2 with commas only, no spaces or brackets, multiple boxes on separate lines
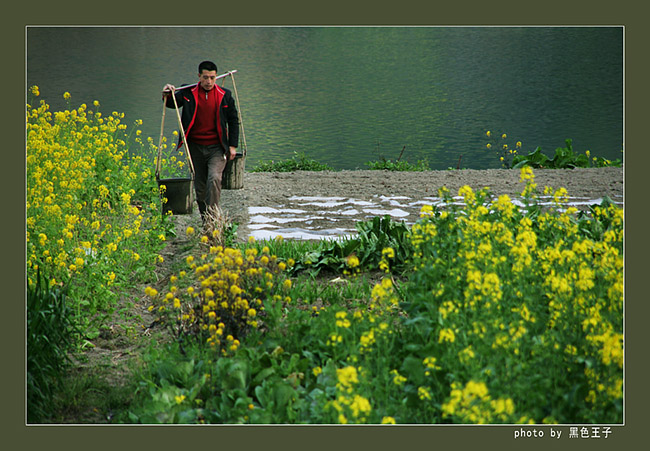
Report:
27,27,623,169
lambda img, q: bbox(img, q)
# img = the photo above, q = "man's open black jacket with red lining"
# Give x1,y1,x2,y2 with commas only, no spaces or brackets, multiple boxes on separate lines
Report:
166,83,239,152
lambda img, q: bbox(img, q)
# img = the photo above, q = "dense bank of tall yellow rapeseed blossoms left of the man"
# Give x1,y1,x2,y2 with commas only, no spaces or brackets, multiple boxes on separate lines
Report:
25,90,164,312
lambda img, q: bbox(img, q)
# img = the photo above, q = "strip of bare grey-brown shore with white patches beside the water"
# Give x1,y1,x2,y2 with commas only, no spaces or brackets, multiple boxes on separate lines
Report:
208,168,624,241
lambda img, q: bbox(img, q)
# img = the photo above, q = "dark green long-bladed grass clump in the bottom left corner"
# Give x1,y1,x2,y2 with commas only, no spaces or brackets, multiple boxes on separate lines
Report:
27,272,75,423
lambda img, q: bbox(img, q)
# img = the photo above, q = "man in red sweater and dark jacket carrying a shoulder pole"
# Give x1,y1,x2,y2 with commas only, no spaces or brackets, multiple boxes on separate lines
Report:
163,61,239,222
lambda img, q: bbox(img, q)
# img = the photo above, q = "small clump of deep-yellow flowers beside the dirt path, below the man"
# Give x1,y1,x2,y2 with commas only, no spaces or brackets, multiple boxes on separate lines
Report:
146,242,293,354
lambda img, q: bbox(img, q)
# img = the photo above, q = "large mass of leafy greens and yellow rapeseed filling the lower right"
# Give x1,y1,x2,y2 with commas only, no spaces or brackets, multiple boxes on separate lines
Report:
123,168,623,424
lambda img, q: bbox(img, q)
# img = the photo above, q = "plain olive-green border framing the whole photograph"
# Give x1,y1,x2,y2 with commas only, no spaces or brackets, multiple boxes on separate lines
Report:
10,0,648,450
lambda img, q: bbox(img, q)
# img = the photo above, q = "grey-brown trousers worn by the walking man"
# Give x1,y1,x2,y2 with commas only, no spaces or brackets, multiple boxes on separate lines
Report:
188,141,228,216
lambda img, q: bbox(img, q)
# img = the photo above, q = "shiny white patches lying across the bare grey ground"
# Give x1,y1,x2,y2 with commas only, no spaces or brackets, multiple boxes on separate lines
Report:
248,195,623,240
